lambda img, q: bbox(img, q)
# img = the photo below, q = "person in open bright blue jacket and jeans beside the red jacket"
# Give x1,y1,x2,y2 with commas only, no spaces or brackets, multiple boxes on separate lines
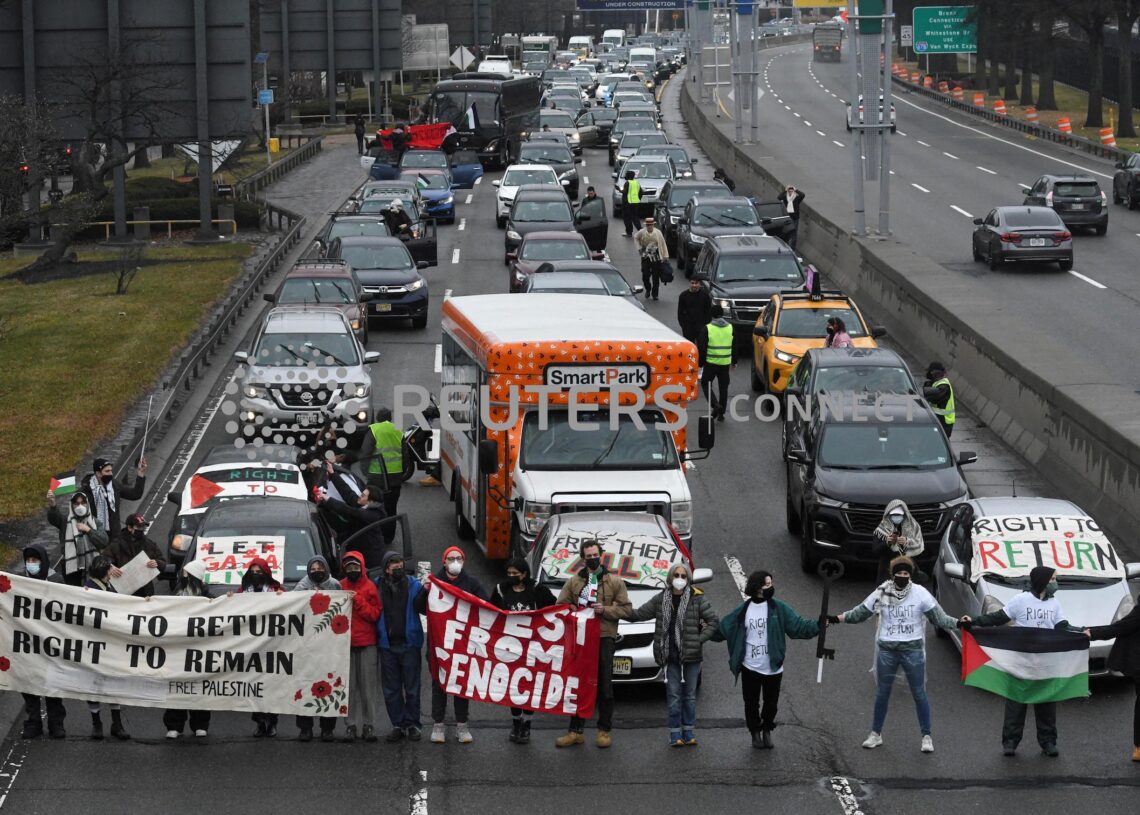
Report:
376,552,424,742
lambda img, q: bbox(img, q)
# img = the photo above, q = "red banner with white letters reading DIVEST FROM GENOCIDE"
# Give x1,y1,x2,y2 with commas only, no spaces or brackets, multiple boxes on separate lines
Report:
425,578,601,718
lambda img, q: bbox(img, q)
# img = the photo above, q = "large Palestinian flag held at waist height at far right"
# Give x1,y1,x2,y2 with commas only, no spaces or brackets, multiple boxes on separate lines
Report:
962,626,1089,704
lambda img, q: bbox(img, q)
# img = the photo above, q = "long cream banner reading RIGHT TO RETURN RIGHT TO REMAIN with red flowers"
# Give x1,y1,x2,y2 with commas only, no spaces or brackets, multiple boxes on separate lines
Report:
0,574,352,716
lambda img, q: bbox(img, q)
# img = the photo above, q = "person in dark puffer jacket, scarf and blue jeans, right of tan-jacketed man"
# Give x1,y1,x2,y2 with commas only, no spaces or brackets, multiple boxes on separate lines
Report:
622,563,720,747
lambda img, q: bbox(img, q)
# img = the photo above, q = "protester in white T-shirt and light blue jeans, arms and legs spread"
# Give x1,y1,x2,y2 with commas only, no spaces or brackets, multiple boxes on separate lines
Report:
828,556,958,752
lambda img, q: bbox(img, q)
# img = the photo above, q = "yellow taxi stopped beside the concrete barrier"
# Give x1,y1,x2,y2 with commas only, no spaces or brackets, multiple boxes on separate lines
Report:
752,290,887,393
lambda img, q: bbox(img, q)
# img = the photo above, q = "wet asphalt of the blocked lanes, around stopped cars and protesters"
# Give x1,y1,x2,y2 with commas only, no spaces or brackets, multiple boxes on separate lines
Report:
0,73,1140,815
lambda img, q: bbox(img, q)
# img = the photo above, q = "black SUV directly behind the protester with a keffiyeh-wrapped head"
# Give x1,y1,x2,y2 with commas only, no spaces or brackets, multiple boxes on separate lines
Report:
785,394,977,572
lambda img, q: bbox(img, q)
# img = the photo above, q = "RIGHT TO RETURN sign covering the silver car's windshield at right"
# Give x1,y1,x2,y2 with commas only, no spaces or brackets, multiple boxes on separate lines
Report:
970,515,1124,580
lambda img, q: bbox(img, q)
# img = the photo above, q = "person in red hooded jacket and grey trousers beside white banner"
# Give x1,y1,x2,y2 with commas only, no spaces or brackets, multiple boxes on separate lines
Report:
341,552,380,741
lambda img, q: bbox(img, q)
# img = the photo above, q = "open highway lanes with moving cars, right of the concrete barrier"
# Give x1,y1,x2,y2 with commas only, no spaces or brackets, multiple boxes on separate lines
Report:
760,47,1140,390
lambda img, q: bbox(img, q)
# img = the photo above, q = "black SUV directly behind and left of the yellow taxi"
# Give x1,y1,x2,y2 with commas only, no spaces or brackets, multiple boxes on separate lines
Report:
694,235,807,349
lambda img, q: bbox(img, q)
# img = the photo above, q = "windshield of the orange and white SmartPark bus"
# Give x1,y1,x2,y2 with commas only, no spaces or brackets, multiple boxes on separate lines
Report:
520,410,677,470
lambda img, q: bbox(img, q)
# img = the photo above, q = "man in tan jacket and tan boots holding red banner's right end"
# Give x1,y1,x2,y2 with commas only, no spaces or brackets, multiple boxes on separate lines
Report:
554,539,633,748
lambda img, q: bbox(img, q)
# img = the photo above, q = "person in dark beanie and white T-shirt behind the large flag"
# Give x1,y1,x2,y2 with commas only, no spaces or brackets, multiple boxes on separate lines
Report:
959,567,1081,757
